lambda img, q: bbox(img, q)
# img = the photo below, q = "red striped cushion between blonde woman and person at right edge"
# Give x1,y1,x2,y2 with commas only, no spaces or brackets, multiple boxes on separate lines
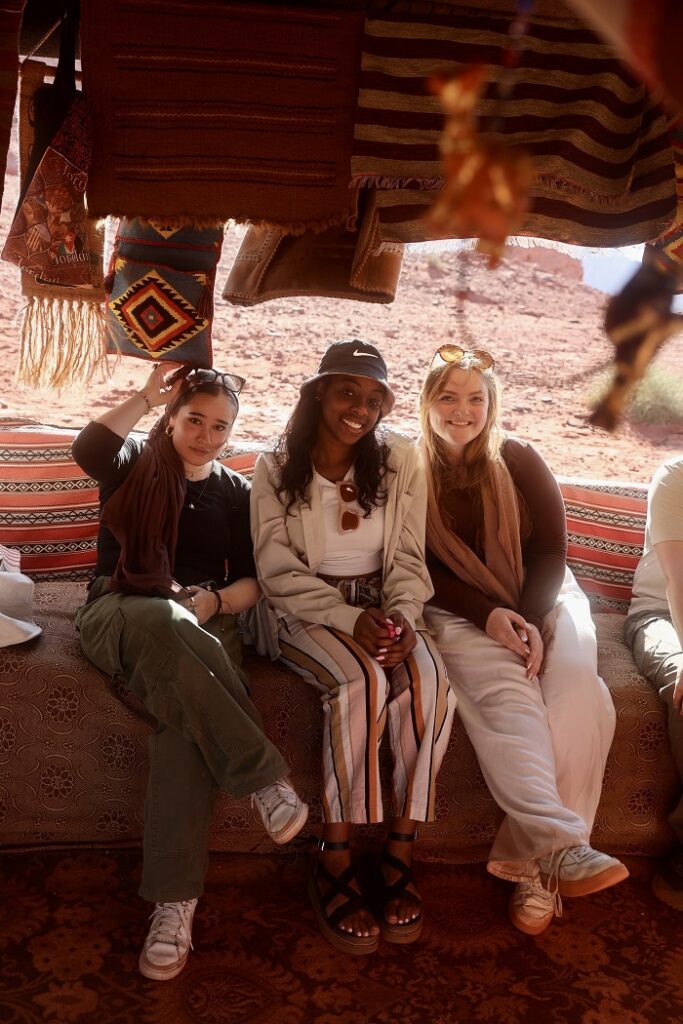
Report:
558,477,647,612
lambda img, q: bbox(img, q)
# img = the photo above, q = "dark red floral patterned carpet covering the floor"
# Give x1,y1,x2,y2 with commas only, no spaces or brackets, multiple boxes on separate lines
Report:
0,851,683,1024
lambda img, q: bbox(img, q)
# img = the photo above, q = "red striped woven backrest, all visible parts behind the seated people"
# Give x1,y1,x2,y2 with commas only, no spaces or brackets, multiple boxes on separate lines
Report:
0,419,647,611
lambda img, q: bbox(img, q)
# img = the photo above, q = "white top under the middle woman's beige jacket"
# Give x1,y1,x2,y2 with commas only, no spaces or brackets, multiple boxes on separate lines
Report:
313,467,384,577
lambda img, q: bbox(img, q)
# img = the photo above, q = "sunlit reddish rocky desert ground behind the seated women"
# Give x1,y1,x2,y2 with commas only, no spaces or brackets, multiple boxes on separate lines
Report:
0,169,683,480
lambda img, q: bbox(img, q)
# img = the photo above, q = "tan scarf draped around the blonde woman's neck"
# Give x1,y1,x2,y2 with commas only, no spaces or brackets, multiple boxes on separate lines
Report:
421,441,524,609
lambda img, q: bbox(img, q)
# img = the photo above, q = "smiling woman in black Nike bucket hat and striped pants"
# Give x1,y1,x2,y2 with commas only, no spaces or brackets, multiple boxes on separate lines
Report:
252,340,455,953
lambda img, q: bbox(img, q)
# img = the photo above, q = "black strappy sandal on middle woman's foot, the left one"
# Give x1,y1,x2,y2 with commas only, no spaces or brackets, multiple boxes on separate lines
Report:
308,840,380,956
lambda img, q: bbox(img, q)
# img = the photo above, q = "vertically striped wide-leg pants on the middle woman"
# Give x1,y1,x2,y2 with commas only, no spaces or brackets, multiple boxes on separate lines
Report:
280,616,456,823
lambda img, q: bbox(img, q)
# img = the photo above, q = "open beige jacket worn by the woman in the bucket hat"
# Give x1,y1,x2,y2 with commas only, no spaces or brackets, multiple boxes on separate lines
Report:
251,432,433,647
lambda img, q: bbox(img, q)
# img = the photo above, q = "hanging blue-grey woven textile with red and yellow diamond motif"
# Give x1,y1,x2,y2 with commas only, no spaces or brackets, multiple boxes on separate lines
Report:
106,219,223,367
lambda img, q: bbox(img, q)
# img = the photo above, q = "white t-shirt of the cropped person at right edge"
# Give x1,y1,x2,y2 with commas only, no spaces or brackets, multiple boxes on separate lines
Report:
629,456,683,617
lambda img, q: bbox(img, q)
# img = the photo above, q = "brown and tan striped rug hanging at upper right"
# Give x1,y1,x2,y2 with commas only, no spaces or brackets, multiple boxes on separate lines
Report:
351,5,676,246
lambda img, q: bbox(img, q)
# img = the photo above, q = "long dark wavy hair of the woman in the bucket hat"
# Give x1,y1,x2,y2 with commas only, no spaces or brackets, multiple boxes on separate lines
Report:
274,387,391,519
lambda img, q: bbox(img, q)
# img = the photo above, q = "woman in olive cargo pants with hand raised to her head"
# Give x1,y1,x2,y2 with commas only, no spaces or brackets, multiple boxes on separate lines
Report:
74,364,307,981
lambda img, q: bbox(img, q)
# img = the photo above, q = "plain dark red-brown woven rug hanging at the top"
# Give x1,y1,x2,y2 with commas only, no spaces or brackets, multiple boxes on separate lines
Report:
81,0,362,231
